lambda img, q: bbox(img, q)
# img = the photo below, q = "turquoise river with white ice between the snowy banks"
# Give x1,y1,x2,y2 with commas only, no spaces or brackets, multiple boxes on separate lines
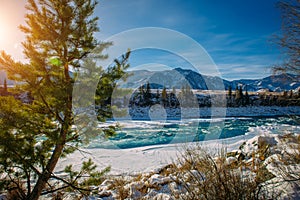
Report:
88,116,300,149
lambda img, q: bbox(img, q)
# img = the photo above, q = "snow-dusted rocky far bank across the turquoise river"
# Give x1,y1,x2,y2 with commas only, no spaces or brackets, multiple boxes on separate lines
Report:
122,105,300,120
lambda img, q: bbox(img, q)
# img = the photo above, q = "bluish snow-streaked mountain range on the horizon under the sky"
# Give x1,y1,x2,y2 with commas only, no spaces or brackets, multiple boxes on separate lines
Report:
119,68,300,92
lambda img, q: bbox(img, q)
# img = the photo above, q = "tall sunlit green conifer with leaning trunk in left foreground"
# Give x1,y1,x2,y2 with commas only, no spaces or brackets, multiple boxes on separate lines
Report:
0,0,125,200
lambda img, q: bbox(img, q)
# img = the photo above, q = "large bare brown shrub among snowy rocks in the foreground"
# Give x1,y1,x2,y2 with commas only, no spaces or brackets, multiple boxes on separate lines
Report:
175,146,262,199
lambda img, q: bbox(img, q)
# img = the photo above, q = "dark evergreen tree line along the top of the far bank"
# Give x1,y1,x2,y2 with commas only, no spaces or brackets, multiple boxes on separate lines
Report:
129,83,300,108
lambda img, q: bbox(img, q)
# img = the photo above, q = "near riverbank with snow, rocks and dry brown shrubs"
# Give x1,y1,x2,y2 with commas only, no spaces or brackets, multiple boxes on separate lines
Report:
52,129,300,200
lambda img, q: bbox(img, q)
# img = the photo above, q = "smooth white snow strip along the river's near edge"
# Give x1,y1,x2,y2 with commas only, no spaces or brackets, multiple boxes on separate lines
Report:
56,127,294,175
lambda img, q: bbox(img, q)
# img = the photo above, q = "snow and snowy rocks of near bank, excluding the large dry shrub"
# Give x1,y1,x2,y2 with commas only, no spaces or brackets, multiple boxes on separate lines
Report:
52,127,300,200
